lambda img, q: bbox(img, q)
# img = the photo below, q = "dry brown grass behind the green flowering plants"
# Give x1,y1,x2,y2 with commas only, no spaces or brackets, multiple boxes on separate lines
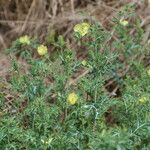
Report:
0,0,150,48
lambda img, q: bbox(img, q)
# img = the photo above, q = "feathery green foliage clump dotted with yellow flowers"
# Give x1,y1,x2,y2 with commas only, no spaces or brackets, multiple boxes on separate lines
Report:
0,5,150,150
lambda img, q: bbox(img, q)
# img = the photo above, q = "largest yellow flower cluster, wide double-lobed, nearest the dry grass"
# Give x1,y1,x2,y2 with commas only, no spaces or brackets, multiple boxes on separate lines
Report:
73,22,90,37
